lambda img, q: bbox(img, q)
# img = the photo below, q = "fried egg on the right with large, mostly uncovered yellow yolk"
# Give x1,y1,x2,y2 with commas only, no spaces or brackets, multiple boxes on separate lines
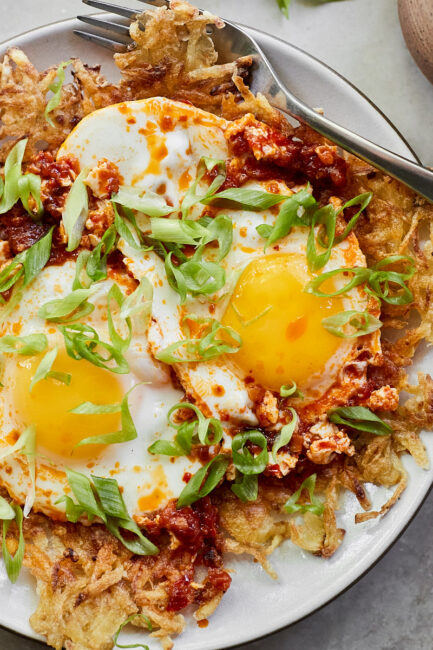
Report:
120,177,380,426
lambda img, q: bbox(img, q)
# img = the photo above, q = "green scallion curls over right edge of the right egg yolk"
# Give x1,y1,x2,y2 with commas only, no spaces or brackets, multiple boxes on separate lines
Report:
304,255,415,305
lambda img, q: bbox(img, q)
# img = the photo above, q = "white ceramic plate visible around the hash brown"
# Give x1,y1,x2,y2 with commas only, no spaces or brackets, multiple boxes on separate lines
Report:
0,15,433,650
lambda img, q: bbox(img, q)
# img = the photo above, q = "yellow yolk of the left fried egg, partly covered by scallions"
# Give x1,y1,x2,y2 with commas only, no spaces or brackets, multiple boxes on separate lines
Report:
14,350,123,459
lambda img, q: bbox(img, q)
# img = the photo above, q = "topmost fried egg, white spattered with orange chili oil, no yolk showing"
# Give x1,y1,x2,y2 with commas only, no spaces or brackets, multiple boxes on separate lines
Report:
57,97,227,206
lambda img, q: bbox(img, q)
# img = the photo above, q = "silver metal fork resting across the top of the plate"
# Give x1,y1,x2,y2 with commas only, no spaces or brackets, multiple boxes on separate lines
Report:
74,0,433,202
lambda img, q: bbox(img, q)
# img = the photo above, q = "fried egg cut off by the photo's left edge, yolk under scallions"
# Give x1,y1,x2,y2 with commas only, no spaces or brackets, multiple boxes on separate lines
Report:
0,262,200,519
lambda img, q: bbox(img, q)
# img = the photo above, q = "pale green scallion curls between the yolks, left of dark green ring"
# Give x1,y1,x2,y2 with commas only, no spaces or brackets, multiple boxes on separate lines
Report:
148,402,223,456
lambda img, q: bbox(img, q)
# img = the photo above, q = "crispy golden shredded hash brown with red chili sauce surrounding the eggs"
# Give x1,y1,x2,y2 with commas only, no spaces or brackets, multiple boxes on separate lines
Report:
0,0,433,650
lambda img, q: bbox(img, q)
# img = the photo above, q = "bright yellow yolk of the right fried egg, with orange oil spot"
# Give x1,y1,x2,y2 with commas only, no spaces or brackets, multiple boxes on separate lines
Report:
222,253,343,391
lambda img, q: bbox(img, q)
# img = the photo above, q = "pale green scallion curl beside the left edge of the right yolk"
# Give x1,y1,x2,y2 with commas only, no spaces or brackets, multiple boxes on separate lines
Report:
156,314,242,363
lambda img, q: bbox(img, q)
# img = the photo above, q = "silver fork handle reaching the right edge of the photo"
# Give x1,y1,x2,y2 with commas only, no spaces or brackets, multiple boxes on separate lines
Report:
273,83,433,202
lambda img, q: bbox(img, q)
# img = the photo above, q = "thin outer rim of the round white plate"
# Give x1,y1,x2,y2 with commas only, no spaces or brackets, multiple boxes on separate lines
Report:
0,12,426,650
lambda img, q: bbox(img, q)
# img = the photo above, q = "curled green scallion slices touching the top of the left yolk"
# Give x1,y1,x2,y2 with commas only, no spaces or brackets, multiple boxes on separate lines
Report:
59,323,129,374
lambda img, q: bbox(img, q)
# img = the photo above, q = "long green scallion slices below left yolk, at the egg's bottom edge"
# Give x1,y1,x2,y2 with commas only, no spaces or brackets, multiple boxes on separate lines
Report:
57,469,158,555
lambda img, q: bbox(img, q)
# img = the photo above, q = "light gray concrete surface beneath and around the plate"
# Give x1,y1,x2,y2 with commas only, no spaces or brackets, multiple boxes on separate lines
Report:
0,0,433,650
